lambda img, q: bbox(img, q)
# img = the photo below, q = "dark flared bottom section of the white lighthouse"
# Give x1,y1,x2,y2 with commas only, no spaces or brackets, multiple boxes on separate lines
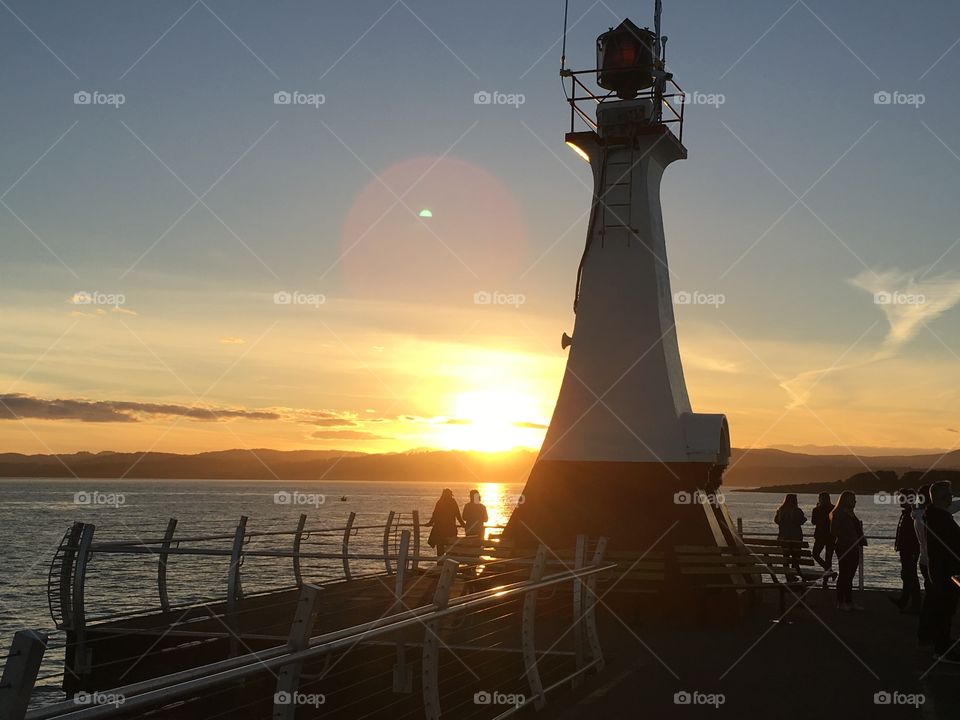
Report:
502,460,732,554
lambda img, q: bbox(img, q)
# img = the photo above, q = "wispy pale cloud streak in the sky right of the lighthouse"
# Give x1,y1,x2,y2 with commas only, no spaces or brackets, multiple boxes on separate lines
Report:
780,268,960,409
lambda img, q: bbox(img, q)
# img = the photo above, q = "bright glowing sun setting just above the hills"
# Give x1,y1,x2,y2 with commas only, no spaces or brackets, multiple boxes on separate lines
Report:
438,389,543,452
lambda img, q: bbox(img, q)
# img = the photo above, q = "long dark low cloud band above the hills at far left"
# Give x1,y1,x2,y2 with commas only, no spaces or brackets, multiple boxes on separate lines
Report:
0,393,283,423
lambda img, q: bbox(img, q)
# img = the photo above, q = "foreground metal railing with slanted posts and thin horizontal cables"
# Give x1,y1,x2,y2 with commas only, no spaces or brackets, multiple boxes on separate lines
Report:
0,530,615,720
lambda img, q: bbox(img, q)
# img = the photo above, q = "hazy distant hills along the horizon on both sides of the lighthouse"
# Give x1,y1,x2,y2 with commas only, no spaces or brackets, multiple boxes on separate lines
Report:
0,448,960,488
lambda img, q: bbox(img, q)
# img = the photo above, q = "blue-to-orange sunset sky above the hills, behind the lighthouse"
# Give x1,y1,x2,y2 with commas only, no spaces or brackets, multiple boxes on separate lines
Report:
0,0,960,453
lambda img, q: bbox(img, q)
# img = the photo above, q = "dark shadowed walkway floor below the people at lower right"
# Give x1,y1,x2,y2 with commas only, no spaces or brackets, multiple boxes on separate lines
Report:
548,588,960,720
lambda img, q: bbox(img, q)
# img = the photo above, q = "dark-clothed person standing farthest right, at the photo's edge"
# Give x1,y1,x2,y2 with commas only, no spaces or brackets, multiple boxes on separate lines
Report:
924,481,960,664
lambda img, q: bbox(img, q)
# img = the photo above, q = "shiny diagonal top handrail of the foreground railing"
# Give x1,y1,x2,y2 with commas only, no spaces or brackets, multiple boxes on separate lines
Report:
26,563,616,720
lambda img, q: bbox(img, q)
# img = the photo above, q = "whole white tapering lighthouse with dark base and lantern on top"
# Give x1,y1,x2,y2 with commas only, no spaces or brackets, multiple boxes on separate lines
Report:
503,0,730,552
